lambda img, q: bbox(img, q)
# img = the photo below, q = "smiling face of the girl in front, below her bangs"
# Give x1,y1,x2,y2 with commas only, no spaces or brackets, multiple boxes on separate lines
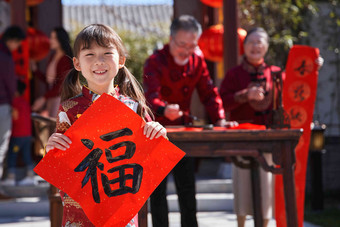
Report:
73,42,125,94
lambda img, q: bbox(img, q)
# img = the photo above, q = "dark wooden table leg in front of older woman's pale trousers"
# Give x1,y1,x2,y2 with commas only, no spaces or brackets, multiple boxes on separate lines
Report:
250,159,263,227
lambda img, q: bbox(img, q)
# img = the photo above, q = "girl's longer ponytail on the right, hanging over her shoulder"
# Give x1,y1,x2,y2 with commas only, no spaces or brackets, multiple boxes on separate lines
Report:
115,66,153,120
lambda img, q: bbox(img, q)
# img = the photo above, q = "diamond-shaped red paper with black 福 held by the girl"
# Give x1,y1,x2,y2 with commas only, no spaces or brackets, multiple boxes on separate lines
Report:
34,94,185,227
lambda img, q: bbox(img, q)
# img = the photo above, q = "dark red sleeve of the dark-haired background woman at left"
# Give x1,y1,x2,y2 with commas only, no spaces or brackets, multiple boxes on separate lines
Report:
45,55,73,99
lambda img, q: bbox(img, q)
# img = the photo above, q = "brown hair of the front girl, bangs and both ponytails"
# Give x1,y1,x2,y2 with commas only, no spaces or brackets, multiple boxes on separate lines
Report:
61,24,153,119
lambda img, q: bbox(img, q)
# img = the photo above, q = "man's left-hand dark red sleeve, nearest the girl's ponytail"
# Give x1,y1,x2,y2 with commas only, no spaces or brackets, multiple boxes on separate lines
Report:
143,54,166,115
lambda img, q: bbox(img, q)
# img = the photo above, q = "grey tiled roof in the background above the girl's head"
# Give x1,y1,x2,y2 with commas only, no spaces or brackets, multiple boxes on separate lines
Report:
63,4,173,36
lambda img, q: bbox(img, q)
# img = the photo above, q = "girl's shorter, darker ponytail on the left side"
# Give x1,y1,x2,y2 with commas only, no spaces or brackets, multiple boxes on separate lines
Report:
61,68,81,101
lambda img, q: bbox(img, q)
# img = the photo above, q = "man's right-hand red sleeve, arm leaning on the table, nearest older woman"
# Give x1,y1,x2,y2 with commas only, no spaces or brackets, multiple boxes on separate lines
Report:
196,58,225,123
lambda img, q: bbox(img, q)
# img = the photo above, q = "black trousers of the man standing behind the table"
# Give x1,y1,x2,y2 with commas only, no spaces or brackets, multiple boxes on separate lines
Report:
150,157,197,227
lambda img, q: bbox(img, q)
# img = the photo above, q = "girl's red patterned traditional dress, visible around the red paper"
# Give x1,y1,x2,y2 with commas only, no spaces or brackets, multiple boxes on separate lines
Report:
56,86,138,227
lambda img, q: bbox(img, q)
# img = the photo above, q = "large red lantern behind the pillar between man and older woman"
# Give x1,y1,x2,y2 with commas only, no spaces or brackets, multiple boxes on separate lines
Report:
198,24,247,61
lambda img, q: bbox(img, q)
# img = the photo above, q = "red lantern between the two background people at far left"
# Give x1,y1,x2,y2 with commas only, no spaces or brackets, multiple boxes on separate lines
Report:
27,28,50,61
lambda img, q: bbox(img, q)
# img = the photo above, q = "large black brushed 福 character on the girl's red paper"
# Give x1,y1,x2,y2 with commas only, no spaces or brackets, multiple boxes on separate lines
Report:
74,128,143,203
